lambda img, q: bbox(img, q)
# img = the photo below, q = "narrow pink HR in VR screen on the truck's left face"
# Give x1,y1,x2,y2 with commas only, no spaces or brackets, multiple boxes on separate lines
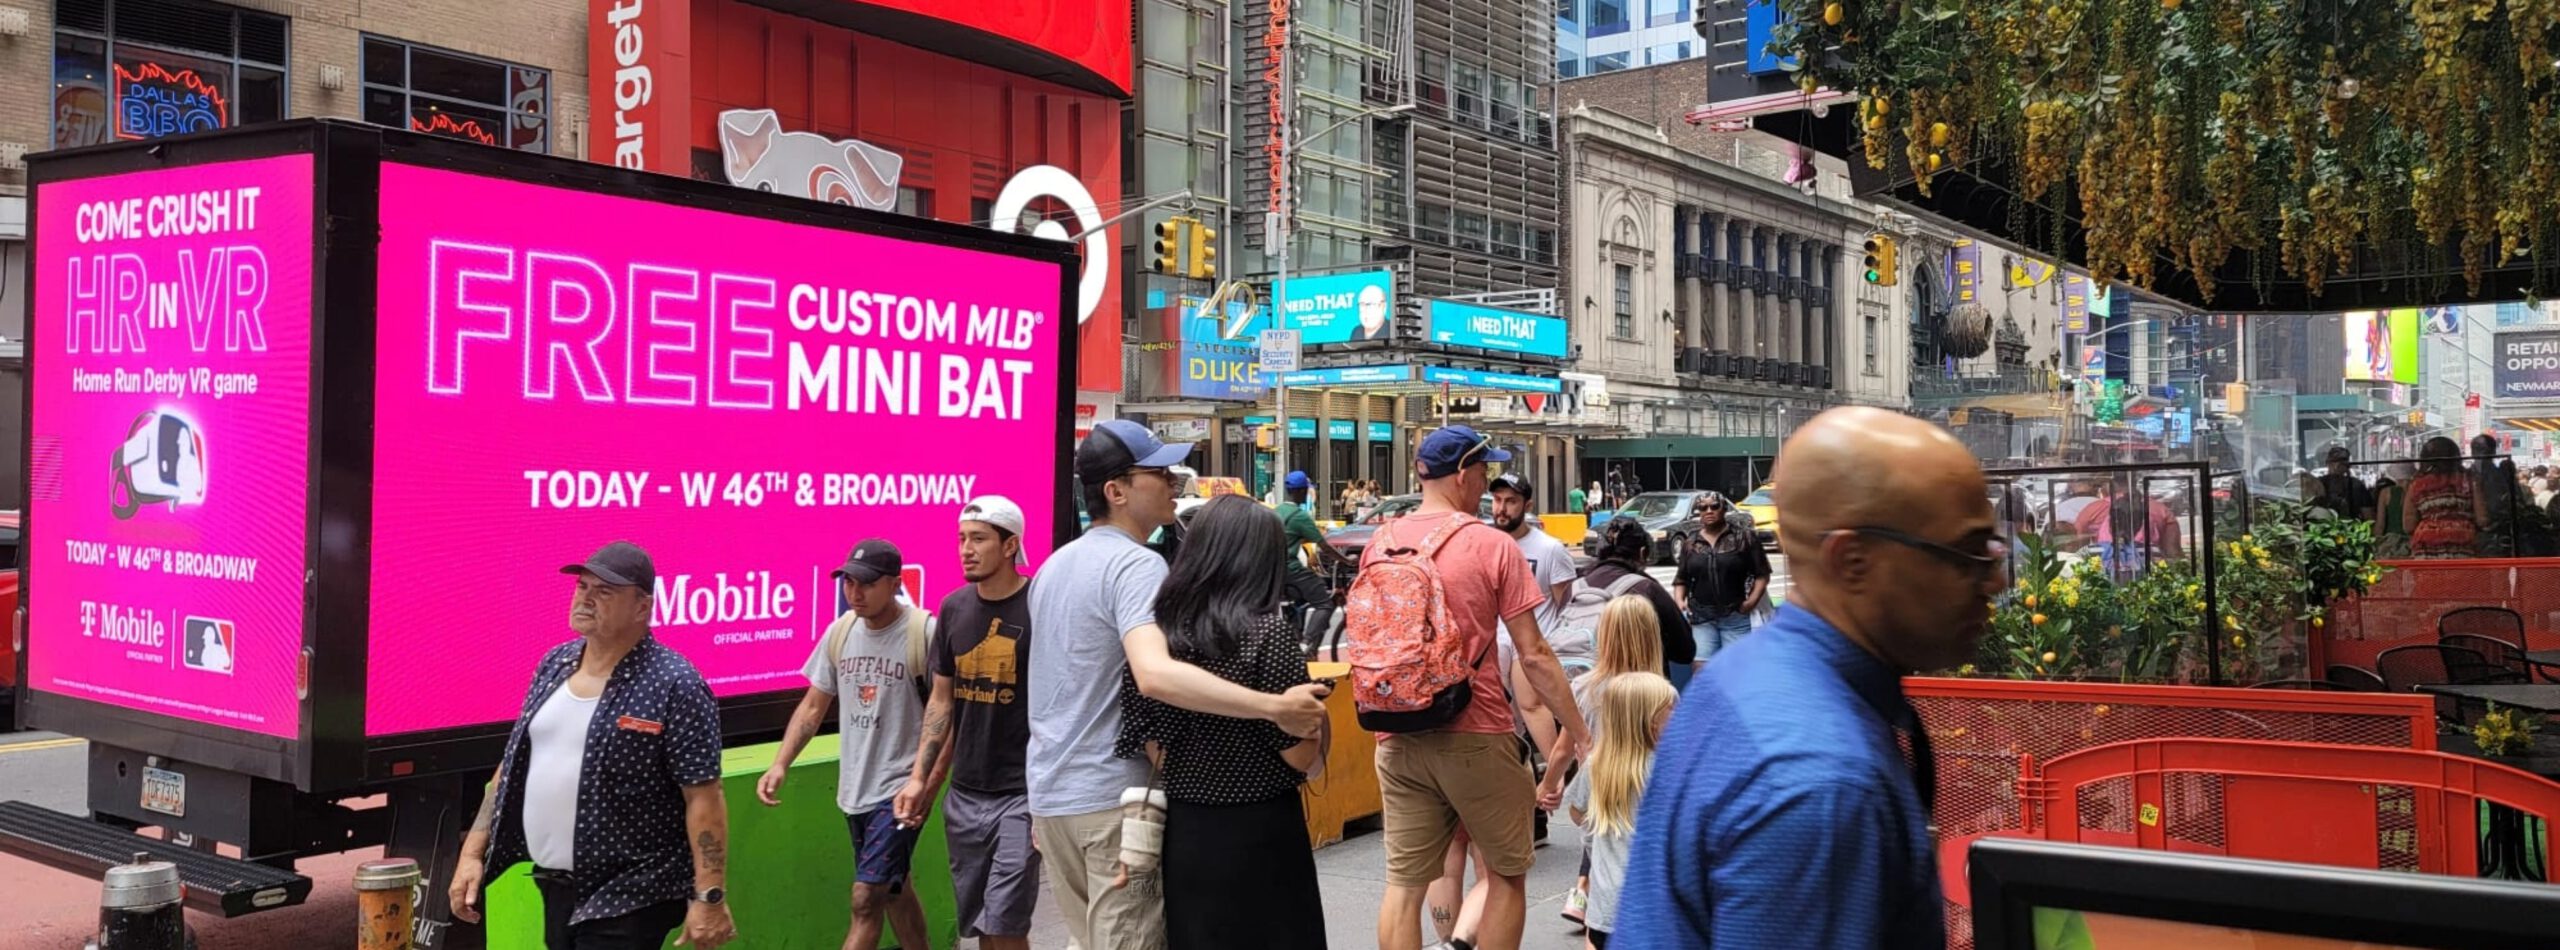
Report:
26,156,312,737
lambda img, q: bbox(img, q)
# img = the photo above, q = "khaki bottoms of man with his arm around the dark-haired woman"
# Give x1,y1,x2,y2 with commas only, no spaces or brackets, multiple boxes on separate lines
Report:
1032,809,1165,950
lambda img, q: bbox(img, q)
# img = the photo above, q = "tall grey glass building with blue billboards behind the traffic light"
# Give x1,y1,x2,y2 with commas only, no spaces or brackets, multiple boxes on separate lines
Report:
1119,0,1580,514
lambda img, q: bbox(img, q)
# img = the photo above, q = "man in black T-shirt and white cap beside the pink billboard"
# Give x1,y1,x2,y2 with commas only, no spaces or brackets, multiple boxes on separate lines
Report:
896,494,1039,950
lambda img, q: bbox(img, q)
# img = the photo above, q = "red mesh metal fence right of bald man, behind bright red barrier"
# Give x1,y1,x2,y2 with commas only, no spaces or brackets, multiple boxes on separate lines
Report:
1902,676,2435,950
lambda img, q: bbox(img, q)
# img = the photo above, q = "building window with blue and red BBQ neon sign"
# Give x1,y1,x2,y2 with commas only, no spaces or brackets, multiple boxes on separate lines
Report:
54,0,292,149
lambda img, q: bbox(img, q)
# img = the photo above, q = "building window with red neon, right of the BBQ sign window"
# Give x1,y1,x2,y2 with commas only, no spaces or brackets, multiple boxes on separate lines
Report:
364,36,550,151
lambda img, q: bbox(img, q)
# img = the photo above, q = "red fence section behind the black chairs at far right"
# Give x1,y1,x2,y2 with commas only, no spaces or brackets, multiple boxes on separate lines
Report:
2309,558,2560,679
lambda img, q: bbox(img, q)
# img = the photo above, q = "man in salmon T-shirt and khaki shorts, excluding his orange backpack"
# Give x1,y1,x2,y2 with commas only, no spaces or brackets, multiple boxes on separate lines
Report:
1352,425,1590,950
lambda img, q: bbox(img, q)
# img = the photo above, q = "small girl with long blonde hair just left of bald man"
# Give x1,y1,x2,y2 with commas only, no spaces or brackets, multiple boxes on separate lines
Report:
1564,673,1679,950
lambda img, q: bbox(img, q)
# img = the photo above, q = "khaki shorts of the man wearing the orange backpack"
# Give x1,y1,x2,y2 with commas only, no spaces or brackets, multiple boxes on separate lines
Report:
1377,732,1539,886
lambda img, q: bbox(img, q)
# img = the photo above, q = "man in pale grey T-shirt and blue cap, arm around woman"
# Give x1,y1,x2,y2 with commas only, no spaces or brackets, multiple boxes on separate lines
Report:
1024,420,1326,950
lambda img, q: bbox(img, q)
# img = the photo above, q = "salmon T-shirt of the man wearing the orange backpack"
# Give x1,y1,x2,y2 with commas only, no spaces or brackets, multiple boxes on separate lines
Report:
1359,512,1546,735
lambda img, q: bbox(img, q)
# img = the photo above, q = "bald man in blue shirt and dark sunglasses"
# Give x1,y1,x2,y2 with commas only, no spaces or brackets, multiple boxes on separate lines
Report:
1610,407,2007,950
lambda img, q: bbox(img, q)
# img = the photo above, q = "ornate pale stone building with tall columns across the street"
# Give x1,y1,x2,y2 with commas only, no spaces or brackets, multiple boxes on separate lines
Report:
1564,101,1910,492
